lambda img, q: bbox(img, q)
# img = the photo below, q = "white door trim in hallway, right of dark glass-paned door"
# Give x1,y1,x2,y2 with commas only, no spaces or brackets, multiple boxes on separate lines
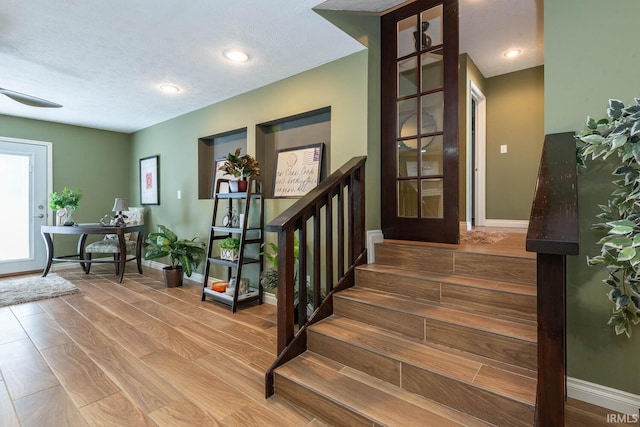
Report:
466,79,487,230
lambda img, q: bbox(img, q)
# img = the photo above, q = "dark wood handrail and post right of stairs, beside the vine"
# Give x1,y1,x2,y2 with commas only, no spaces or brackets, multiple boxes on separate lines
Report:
526,133,579,427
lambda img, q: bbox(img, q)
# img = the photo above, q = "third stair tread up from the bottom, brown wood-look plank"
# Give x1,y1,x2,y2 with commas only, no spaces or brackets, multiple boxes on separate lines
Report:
335,287,537,343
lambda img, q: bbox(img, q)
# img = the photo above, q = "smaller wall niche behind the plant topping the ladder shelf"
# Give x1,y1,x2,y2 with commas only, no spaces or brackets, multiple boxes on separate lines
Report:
198,128,247,199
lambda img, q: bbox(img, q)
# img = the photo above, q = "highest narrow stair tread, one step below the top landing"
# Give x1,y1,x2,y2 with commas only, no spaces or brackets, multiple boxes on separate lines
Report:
357,264,537,296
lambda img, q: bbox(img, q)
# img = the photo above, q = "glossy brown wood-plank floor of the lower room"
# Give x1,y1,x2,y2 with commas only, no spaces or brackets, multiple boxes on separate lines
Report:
0,252,632,427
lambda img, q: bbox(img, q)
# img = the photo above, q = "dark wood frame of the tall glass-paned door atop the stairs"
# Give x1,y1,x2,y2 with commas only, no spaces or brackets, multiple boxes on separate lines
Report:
380,0,461,244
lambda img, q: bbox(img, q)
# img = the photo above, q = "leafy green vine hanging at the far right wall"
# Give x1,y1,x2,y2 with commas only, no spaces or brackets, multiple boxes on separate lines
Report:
577,98,640,337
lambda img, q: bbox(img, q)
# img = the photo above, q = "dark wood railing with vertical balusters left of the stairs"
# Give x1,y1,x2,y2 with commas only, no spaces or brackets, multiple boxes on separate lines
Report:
265,157,367,397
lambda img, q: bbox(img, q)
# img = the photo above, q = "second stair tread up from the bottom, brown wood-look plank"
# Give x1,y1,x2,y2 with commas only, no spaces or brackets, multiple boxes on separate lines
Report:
312,316,536,405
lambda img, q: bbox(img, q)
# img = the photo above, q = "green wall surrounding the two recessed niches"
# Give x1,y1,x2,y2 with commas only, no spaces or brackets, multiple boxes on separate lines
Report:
129,50,368,271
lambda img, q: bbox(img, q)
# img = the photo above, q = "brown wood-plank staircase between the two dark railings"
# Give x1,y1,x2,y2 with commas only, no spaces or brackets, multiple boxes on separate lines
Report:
275,238,536,427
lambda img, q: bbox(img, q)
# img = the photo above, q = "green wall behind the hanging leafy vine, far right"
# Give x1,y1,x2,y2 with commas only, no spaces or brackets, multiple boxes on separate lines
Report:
544,0,640,394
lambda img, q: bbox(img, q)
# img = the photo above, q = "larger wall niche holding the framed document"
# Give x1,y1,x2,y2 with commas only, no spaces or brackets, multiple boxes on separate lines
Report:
256,107,331,198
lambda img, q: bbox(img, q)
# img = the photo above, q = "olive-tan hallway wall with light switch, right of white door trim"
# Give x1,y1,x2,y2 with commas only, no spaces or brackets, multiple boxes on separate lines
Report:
485,66,544,220
